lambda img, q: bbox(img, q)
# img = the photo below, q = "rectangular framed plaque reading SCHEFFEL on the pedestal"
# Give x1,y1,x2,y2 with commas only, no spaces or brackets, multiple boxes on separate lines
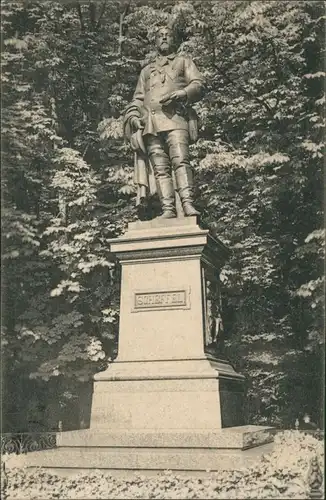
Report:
133,289,189,311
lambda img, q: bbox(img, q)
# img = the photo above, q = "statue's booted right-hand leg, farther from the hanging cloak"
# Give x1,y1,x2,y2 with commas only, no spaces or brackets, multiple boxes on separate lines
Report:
167,130,199,216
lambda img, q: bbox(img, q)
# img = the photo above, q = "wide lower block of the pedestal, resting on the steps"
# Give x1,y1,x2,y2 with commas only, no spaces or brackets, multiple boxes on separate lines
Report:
91,356,244,432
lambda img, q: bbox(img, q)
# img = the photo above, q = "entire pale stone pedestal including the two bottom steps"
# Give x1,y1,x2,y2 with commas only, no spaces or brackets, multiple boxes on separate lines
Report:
19,217,272,471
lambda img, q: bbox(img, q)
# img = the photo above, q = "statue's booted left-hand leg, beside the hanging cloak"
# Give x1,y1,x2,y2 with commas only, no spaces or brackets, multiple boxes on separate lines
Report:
146,135,176,219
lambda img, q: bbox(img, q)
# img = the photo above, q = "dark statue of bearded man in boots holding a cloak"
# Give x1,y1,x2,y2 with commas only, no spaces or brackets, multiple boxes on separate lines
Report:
124,27,204,219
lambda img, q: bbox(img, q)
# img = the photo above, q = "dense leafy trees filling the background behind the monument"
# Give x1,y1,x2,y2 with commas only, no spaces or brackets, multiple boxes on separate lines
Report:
1,0,325,430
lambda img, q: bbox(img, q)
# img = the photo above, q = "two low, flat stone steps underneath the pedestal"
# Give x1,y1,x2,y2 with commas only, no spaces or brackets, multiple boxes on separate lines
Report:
10,426,273,474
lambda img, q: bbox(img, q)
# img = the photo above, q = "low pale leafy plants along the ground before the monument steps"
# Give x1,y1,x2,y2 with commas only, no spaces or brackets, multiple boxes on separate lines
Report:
7,431,324,500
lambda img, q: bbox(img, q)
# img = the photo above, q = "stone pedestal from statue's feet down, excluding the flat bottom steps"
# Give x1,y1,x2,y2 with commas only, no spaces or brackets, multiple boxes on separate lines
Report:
91,217,244,431
